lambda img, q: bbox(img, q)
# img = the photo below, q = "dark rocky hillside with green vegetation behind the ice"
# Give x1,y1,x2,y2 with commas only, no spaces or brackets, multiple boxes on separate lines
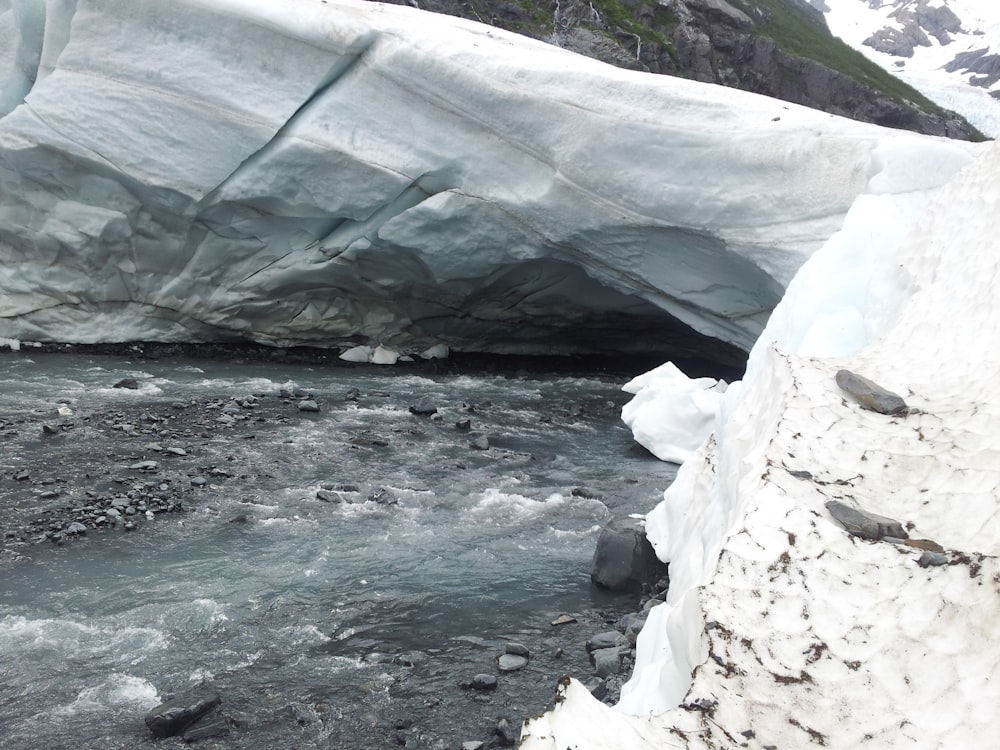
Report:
380,0,983,140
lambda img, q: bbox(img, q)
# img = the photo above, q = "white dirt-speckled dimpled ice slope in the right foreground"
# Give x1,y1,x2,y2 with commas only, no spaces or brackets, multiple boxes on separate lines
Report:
522,140,1000,750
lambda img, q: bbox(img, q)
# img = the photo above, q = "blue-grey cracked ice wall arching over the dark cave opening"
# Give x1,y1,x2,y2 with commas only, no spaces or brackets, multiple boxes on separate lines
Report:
0,0,976,353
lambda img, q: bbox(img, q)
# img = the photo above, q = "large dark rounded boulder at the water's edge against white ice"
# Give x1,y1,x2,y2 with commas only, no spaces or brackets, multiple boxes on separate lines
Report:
590,517,667,592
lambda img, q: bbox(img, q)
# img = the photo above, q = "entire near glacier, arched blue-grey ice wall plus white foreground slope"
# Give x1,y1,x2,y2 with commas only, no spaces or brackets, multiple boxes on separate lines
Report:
0,0,1000,750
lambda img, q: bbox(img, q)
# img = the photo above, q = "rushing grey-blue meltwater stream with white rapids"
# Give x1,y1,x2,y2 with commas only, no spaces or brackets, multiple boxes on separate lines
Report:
0,353,672,750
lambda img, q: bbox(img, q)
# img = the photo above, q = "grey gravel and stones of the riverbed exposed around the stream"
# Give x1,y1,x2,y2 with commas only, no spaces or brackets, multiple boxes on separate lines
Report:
0,348,665,749
